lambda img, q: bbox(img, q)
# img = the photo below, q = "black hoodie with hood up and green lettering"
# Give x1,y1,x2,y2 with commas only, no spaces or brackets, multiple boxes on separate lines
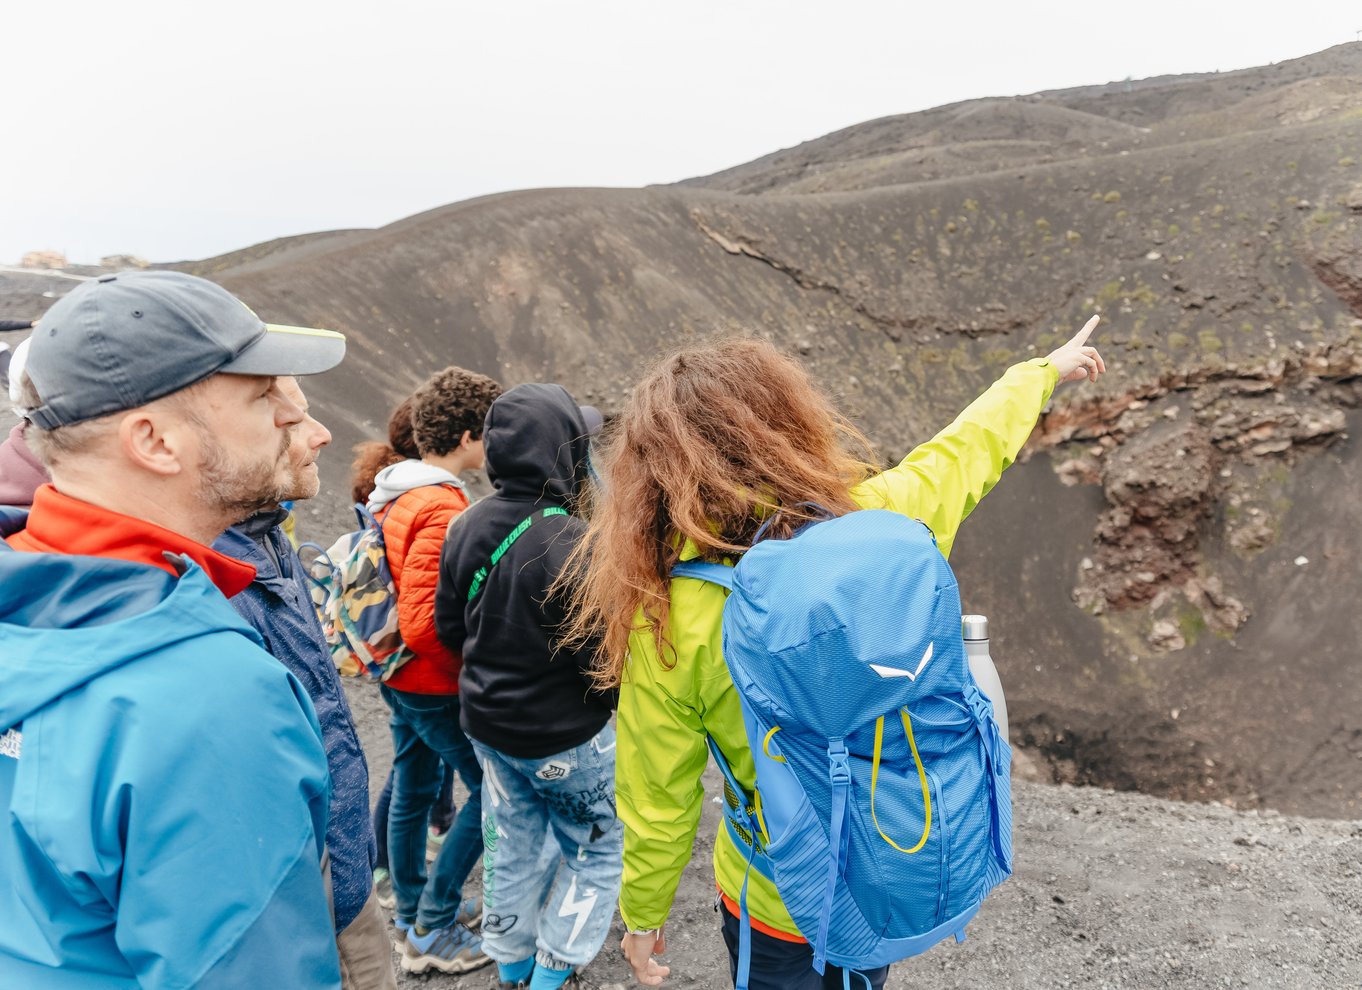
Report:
434,384,610,759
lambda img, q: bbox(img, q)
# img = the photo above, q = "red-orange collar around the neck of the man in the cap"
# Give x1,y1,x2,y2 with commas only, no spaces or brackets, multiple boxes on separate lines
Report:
7,485,255,598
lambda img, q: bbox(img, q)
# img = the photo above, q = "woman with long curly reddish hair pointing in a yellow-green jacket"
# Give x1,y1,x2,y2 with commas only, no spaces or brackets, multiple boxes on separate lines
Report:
564,317,1106,990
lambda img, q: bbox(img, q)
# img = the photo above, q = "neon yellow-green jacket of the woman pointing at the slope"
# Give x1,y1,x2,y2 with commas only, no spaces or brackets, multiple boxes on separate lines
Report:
616,358,1058,937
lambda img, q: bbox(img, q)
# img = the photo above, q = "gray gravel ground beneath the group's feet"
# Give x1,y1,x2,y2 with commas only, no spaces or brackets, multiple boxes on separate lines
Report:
346,682,1362,990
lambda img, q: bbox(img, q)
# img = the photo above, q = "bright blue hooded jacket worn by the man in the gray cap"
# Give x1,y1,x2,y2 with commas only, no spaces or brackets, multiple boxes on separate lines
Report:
0,509,341,990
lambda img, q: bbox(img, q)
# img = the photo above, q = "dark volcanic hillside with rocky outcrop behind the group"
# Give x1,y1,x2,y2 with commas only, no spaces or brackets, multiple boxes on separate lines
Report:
21,45,1362,817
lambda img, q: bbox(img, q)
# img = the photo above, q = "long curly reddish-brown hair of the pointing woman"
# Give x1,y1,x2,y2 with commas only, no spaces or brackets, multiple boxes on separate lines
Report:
560,339,878,688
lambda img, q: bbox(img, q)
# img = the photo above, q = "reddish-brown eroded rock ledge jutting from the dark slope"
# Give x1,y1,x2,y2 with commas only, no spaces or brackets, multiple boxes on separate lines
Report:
1031,334,1362,651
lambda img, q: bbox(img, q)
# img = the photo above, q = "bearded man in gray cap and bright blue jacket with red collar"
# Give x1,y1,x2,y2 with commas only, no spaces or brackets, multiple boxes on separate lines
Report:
0,272,345,987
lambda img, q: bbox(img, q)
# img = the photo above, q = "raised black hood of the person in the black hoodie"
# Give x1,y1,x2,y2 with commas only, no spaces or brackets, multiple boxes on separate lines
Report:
482,384,591,502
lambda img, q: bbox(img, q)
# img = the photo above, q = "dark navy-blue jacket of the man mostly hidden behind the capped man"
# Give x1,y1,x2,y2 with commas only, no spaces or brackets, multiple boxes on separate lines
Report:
212,511,377,931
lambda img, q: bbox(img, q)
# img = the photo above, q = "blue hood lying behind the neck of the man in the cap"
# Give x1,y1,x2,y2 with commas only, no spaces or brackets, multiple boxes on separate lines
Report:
0,512,260,729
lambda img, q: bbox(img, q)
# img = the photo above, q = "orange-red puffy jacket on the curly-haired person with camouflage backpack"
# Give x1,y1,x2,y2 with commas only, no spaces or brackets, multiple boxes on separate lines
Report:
377,485,469,694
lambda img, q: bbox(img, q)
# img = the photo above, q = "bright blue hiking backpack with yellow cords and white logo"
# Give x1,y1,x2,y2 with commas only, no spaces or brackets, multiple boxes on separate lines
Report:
671,509,1012,990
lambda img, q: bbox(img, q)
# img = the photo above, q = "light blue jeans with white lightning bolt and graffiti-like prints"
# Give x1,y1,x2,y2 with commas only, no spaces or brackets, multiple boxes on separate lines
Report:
473,724,624,970
